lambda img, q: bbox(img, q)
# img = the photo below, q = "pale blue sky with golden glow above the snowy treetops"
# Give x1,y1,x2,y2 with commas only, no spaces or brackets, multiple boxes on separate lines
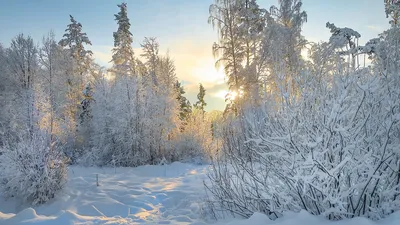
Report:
0,0,389,110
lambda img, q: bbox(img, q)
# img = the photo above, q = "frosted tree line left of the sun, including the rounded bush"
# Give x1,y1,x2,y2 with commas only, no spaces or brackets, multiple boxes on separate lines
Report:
0,3,219,204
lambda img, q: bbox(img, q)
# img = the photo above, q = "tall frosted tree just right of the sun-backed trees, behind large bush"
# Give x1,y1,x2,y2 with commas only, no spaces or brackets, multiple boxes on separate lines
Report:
260,0,307,105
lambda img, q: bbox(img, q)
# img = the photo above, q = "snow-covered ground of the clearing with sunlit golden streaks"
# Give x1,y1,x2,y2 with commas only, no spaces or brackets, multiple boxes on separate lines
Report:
0,163,400,225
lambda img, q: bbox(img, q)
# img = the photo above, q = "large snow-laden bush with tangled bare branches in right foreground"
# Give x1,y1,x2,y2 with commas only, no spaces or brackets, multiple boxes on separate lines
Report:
207,70,400,220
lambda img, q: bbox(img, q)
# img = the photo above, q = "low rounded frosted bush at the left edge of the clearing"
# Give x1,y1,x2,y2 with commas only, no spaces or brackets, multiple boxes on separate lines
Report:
0,131,67,205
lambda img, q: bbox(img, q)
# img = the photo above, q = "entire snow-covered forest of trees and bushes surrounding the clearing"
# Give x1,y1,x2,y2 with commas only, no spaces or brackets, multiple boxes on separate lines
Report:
0,0,400,223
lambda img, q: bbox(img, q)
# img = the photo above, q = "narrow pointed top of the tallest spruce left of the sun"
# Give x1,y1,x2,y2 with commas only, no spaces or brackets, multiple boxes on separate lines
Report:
112,3,136,76
